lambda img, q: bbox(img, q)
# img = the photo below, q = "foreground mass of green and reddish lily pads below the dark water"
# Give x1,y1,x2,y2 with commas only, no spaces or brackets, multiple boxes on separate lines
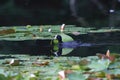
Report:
0,50,120,80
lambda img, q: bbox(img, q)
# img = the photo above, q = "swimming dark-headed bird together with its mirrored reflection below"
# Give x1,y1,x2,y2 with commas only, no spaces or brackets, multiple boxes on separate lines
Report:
53,33,91,56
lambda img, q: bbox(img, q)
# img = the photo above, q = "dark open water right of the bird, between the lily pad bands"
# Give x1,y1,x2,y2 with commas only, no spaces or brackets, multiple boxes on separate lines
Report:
63,32,120,57
